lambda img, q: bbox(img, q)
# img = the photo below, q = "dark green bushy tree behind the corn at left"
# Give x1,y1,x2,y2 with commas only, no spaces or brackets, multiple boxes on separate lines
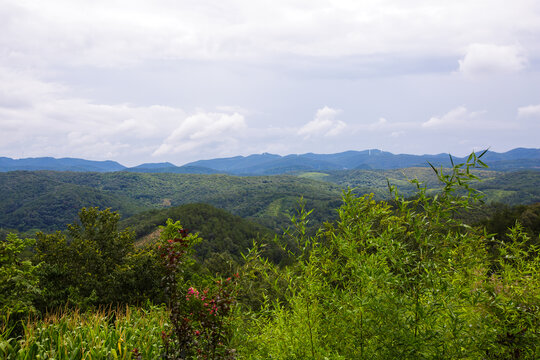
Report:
35,208,162,309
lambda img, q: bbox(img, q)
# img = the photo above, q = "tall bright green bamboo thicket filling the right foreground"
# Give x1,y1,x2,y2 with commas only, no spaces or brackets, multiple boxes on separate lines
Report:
236,154,540,359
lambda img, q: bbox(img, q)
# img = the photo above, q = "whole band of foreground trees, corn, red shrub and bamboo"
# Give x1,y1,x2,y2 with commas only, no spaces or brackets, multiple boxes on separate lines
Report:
0,154,540,359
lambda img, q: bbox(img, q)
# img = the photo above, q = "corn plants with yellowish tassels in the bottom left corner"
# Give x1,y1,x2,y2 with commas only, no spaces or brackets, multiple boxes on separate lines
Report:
0,307,167,360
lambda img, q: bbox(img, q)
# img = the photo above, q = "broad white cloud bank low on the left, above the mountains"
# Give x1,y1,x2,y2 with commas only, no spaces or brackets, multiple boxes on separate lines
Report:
0,68,253,163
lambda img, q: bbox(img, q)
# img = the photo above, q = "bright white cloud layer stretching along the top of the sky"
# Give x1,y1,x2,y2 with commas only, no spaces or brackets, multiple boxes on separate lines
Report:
0,0,540,66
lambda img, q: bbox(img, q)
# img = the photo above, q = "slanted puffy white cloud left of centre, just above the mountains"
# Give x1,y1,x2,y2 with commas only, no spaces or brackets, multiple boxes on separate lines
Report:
153,112,246,156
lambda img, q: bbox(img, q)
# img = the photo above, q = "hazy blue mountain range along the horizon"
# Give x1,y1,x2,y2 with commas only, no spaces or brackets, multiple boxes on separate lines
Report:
0,148,540,175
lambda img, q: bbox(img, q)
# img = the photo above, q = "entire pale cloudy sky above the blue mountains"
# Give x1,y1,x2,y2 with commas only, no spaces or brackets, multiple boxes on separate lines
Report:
0,0,540,166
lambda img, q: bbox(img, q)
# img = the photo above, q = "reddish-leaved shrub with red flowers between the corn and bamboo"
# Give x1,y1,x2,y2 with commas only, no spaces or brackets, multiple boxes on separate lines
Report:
159,219,238,359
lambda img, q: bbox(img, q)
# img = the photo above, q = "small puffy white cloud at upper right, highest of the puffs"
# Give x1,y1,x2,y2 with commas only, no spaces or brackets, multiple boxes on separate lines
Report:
459,44,528,75
